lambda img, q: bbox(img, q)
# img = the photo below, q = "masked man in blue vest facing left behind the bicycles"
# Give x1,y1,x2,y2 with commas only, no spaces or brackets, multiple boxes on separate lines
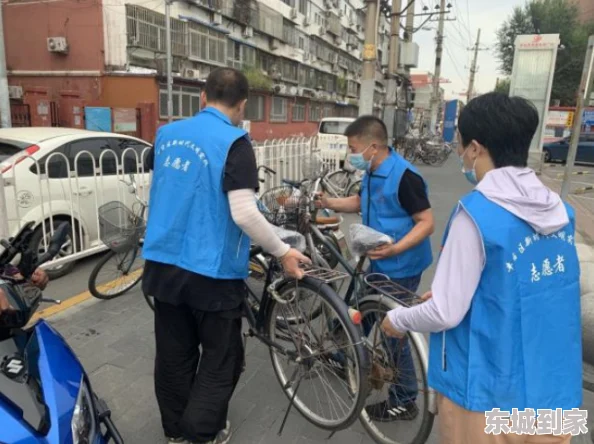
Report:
319,116,433,421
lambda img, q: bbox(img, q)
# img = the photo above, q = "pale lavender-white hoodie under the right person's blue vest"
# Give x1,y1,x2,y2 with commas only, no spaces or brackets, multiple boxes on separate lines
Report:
389,167,569,333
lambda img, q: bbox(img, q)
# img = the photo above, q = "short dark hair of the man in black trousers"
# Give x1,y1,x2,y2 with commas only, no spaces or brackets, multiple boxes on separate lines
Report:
204,68,249,107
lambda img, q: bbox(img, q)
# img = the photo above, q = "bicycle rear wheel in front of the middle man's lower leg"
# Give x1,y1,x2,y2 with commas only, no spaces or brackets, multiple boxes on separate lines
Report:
359,297,434,444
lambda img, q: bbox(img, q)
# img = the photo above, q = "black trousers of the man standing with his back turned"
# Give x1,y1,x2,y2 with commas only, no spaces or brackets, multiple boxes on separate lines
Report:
155,300,244,442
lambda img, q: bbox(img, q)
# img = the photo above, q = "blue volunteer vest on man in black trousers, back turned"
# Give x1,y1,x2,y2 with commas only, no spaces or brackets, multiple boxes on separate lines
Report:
144,108,250,279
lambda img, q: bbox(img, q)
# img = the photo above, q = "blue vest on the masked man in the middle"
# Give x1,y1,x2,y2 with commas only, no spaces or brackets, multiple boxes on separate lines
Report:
361,148,433,279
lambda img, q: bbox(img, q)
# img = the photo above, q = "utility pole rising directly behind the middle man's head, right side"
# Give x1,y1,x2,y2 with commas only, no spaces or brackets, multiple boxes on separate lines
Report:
384,0,401,141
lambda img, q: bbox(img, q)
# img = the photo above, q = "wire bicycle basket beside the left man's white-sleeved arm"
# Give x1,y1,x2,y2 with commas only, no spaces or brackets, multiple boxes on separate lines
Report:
259,186,299,229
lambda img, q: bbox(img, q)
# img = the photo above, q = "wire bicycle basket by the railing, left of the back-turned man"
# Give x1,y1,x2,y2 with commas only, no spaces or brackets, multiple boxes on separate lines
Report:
99,201,146,253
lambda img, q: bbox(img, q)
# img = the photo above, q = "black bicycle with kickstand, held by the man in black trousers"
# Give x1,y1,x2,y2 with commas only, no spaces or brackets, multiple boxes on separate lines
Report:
244,232,368,434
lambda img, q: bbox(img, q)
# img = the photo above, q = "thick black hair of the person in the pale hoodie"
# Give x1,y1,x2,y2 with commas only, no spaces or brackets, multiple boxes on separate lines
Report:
458,92,539,168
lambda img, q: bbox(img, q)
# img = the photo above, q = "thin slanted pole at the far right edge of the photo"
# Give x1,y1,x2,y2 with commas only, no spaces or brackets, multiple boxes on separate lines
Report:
561,35,594,200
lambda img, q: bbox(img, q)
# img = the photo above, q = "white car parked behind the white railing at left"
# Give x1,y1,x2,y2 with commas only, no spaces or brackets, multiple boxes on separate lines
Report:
0,127,151,278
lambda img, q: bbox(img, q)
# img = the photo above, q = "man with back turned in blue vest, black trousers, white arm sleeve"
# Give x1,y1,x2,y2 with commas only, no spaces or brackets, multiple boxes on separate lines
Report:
143,68,308,444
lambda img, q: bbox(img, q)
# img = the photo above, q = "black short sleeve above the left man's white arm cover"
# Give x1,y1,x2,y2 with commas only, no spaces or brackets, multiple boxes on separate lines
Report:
223,137,260,193
